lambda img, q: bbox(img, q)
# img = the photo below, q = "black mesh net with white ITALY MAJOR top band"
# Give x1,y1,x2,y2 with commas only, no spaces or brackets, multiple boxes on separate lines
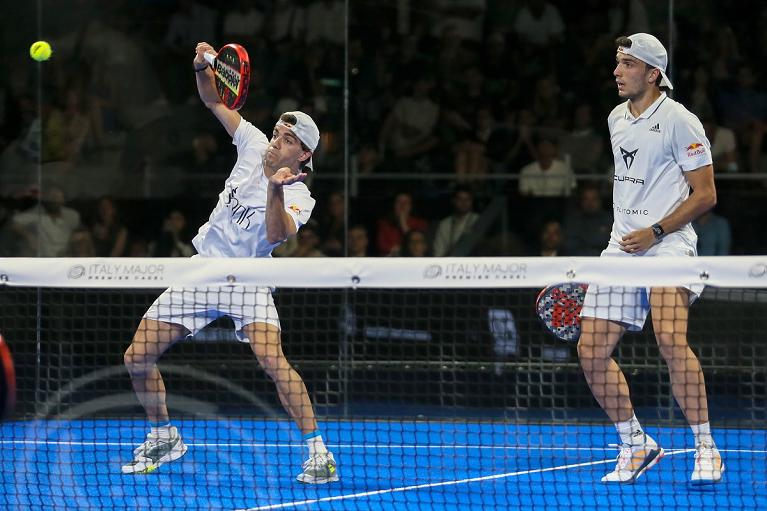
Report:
0,258,767,509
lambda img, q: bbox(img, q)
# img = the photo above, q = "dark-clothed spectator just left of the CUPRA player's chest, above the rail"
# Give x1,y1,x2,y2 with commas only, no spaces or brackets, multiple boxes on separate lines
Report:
560,103,605,174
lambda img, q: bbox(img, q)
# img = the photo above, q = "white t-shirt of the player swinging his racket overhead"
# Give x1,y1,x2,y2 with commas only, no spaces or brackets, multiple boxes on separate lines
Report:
192,119,315,257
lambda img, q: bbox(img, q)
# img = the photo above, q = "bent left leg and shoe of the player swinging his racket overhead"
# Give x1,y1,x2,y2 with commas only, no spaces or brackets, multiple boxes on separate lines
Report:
122,319,188,474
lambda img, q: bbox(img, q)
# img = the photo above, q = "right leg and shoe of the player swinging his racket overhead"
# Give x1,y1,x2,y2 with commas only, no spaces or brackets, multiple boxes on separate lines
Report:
242,323,338,484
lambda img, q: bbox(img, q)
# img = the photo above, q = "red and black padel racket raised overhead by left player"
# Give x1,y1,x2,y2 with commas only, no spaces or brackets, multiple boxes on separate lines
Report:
205,43,250,110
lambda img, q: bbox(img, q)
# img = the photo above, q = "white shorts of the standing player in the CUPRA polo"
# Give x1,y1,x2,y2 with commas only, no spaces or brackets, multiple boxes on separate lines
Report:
581,238,703,332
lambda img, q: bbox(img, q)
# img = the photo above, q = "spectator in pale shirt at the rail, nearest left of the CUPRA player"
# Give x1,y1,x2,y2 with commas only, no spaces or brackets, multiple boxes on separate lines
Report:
519,137,575,197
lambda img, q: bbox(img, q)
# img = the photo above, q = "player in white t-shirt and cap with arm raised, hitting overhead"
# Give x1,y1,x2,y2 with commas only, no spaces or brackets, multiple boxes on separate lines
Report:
122,43,338,483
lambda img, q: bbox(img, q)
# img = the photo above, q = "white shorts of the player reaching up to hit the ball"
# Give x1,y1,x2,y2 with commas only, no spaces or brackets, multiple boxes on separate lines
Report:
144,286,280,342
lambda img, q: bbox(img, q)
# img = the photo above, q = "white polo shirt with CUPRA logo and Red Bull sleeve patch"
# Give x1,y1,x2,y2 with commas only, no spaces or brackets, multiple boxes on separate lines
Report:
607,93,711,247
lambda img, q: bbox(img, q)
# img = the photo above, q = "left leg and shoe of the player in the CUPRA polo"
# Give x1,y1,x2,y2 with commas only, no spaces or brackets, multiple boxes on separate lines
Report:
578,317,663,483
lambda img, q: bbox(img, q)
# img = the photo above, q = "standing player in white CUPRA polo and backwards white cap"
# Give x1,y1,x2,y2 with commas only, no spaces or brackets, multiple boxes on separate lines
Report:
578,34,724,483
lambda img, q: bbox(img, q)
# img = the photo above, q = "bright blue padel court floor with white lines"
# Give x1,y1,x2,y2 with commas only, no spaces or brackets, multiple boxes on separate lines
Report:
0,419,767,511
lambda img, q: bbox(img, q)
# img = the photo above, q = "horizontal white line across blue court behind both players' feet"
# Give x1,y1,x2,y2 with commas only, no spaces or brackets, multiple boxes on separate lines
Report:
0,440,767,454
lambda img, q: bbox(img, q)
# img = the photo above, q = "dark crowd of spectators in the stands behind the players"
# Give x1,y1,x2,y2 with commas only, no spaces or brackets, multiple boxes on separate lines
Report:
0,0,767,257
